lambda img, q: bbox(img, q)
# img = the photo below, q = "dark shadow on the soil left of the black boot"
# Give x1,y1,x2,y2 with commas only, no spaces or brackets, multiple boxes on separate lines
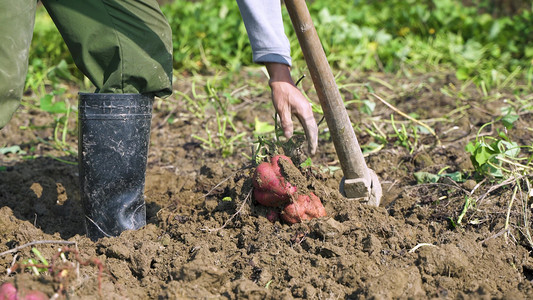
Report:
0,156,160,239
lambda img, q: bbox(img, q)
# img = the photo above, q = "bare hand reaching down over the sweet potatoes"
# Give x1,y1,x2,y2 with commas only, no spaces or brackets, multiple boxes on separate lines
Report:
266,63,318,154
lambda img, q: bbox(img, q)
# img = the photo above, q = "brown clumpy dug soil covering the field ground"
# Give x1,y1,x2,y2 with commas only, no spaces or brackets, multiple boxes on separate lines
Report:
0,69,533,299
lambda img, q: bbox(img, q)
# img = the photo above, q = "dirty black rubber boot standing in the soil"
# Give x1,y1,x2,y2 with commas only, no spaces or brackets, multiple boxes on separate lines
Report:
78,93,153,240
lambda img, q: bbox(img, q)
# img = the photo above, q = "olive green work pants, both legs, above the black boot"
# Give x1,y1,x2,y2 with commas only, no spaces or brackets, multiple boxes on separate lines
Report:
0,0,172,128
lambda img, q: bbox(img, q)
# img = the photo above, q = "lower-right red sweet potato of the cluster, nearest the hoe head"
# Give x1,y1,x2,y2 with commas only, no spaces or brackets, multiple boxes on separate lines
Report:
281,192,326,224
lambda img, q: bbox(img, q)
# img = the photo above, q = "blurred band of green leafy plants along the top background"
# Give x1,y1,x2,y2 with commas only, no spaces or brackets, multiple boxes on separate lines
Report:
27,0,533,90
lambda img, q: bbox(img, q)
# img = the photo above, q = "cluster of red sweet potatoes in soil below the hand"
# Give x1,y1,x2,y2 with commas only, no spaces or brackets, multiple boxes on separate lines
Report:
253,155,326,224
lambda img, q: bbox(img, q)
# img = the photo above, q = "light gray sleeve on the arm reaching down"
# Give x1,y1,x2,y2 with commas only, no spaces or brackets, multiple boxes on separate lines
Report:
237,0,291,66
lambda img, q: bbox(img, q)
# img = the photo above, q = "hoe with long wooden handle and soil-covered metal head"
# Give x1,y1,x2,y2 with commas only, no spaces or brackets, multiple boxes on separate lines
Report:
285,0,382,206
